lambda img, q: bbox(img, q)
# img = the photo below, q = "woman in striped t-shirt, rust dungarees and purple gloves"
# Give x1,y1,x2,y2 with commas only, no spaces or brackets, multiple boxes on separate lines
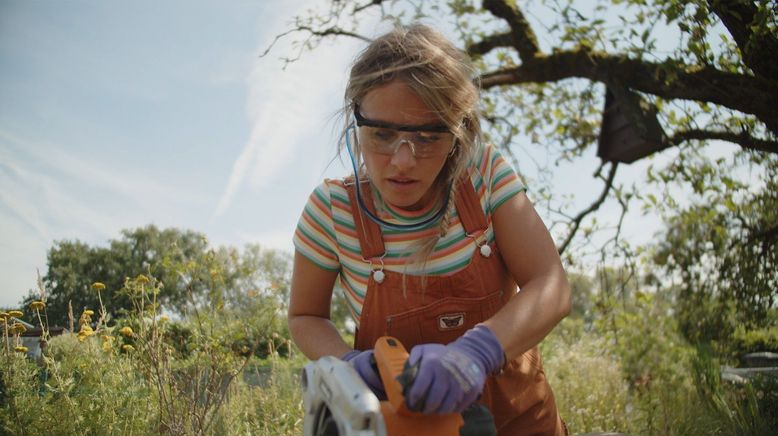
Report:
289,25,570,435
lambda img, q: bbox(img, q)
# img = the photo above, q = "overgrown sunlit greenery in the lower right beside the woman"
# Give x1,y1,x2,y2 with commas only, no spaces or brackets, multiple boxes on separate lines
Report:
541,286,778,435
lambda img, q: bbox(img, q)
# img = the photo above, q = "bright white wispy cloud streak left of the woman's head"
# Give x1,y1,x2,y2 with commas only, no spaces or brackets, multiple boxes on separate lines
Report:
214,26,354,217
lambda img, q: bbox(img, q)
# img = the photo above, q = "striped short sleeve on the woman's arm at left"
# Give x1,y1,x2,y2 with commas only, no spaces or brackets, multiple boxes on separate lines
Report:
293,181,340,271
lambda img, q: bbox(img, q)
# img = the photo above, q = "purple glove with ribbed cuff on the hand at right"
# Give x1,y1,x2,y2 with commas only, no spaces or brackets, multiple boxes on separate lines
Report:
399,325,504,414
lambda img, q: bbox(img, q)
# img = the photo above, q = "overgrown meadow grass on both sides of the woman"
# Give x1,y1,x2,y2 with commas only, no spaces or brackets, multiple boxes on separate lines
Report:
0,276,778,436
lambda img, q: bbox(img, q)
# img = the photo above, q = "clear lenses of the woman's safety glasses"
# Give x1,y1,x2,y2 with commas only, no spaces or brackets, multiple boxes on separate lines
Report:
357,126,454,158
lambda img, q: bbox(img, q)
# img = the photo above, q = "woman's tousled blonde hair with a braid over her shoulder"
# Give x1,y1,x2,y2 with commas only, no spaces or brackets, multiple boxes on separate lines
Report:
341,24,481,269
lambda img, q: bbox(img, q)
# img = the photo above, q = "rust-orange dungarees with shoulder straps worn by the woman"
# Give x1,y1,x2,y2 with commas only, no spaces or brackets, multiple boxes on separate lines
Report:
345,177,566,436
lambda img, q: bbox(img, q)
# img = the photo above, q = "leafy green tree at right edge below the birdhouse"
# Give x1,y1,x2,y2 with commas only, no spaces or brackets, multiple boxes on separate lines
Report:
654,158,778,342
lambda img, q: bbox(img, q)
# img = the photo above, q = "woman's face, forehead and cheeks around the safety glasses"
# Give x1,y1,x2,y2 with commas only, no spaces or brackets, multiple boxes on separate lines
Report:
359,80,448,210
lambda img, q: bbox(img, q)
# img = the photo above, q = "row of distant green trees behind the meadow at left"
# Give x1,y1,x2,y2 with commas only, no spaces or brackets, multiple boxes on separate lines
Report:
25,225,291,326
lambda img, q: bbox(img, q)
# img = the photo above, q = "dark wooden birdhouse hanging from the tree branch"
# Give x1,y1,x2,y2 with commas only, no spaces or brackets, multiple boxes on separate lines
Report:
597,86,665,163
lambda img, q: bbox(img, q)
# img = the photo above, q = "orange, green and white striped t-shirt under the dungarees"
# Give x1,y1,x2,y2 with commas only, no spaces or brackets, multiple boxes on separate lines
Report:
294,145,525,326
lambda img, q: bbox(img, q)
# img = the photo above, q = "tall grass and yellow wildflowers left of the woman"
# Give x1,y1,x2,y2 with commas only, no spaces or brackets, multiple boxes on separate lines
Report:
0,276,303,435
